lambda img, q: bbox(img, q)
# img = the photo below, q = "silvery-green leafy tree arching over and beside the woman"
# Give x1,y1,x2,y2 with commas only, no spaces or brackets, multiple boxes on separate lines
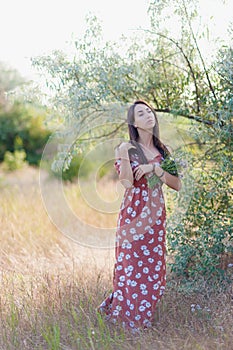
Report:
34,4,233,278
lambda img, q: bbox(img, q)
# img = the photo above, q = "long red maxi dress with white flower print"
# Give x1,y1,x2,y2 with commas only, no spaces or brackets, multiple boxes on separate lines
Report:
98,152,166,331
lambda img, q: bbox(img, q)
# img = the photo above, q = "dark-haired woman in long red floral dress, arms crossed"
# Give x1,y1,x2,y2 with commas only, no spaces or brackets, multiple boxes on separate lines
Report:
98,101,181,331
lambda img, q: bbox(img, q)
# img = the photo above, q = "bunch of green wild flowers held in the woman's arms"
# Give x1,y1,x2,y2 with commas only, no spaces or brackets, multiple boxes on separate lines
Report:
147,156,187,188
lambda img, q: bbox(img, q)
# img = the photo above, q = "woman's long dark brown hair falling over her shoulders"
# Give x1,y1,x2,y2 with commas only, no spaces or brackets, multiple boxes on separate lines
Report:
127,100,170,164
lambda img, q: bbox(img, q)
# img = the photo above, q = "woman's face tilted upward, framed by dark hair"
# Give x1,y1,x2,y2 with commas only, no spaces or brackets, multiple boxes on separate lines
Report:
134,103,155,130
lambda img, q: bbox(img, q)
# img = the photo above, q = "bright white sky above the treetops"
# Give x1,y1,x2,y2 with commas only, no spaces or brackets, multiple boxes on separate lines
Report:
0,0,233,78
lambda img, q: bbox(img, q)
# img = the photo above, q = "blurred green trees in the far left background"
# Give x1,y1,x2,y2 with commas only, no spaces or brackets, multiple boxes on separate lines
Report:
0,63,51,165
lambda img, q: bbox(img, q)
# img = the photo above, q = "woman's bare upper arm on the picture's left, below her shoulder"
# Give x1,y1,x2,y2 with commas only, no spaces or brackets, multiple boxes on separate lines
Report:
115,142,134,188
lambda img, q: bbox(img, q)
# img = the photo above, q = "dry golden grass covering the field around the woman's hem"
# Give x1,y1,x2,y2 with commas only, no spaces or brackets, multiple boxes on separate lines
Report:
0,165,233,350
